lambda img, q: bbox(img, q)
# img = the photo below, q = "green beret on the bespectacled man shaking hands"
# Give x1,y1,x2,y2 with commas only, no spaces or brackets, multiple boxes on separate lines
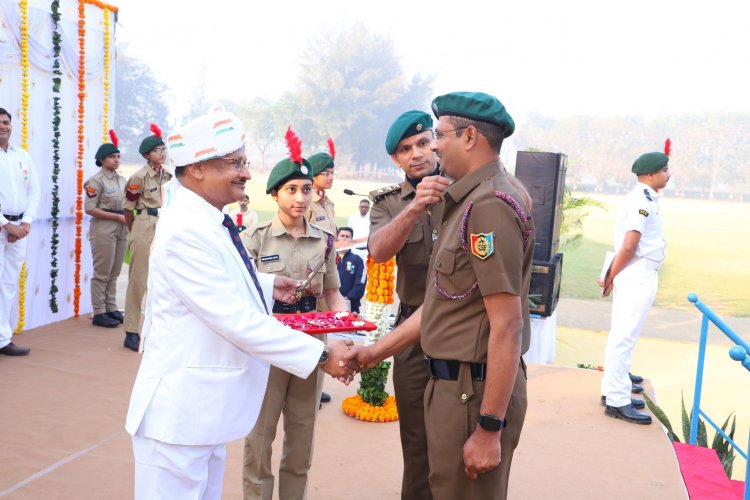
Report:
432,92,516,137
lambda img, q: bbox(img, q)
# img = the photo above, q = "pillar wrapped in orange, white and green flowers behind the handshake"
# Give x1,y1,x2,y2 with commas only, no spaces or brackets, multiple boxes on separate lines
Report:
341,255,398,422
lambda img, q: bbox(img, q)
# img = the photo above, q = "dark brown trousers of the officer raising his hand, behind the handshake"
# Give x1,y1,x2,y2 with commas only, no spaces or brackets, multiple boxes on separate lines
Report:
393,342,432,500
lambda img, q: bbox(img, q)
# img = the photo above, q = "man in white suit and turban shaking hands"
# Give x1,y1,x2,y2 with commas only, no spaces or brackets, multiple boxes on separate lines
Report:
125,110,351,500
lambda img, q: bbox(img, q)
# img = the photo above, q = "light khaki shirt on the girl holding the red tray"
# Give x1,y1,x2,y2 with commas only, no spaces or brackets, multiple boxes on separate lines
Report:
240,215,341,297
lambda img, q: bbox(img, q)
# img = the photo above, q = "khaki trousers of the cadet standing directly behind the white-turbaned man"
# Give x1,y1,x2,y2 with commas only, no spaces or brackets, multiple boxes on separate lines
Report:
123,211,159,333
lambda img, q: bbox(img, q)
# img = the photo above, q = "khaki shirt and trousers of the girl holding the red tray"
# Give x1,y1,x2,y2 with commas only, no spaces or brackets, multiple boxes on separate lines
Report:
241,215,341,500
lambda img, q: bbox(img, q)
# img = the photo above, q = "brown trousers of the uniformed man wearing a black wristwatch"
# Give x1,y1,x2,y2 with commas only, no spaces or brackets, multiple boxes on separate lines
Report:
424,362,527,500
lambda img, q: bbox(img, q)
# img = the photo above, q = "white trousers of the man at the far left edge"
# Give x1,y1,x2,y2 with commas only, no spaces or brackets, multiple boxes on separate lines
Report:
0,225,28,348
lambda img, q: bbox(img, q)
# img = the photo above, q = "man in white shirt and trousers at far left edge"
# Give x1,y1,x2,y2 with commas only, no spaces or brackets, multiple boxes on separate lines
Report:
0,108,39,356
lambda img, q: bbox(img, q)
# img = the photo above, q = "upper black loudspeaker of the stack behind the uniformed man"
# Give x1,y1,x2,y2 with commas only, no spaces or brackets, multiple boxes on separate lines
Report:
516,151,568,262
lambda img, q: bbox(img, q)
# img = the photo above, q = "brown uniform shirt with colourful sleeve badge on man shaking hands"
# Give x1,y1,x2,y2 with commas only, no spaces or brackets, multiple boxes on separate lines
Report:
421,161,534,363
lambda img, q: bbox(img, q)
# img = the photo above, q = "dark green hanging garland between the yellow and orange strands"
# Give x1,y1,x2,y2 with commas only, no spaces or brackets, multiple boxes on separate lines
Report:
49,0,62,313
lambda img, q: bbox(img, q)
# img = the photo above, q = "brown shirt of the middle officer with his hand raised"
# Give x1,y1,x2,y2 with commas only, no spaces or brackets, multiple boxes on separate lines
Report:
370,181,438,307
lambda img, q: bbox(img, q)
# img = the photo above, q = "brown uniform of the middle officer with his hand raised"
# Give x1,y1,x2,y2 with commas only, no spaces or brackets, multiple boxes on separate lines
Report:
370,182,437,500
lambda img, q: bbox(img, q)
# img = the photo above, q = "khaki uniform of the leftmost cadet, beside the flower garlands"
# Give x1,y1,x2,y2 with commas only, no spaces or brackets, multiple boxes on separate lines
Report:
83,169,128,315
